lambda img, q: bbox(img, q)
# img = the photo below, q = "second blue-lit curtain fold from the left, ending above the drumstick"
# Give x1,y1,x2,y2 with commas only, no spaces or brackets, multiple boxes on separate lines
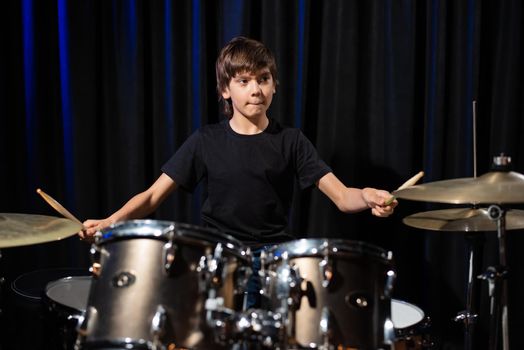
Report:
58,0,75,207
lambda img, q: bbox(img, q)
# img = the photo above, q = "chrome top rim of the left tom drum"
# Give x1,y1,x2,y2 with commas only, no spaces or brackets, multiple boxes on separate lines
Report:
95,219,249,260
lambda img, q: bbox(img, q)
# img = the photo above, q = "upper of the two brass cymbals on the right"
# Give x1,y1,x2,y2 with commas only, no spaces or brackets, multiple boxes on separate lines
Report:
393,171,524,204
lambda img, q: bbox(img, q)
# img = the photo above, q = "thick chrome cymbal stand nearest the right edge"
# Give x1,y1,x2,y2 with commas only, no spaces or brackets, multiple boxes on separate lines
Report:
479,205,509,350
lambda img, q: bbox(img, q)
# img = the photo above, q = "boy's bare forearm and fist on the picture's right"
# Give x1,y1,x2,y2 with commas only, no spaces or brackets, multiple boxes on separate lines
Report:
317,173,398,217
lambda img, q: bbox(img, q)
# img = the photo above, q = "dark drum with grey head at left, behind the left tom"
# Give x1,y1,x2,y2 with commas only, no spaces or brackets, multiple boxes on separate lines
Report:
43,276,91,350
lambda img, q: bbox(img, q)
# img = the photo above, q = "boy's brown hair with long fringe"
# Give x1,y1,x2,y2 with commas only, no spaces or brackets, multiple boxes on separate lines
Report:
216,36,278,117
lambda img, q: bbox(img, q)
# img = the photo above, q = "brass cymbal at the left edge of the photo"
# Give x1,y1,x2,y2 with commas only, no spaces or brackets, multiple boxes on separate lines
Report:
0,213,82,248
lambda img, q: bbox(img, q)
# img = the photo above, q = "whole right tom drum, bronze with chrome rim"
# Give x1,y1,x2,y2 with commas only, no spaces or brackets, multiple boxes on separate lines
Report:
261,239,395,350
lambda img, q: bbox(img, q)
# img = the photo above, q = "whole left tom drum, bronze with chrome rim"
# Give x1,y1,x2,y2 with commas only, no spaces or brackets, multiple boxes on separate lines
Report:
79,220,251,349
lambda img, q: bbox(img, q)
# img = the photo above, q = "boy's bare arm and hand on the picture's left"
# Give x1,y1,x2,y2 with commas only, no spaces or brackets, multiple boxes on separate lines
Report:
79,173,176,238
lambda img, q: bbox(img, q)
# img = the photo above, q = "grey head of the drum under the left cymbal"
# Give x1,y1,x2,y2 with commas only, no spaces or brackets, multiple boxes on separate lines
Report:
45,276,91,312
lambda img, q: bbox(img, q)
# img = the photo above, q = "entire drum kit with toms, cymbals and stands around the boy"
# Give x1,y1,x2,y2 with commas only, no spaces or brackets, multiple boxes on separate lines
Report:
0,154,524,350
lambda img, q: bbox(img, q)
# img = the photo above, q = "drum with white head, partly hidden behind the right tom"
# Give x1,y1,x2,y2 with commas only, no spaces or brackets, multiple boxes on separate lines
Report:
391,299,432,350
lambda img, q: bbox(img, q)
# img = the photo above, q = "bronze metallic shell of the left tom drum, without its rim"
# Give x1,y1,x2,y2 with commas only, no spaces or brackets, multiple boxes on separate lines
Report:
85,221,252,348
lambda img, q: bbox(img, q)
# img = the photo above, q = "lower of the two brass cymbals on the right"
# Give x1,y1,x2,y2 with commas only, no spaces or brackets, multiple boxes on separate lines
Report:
402,208,524,232
